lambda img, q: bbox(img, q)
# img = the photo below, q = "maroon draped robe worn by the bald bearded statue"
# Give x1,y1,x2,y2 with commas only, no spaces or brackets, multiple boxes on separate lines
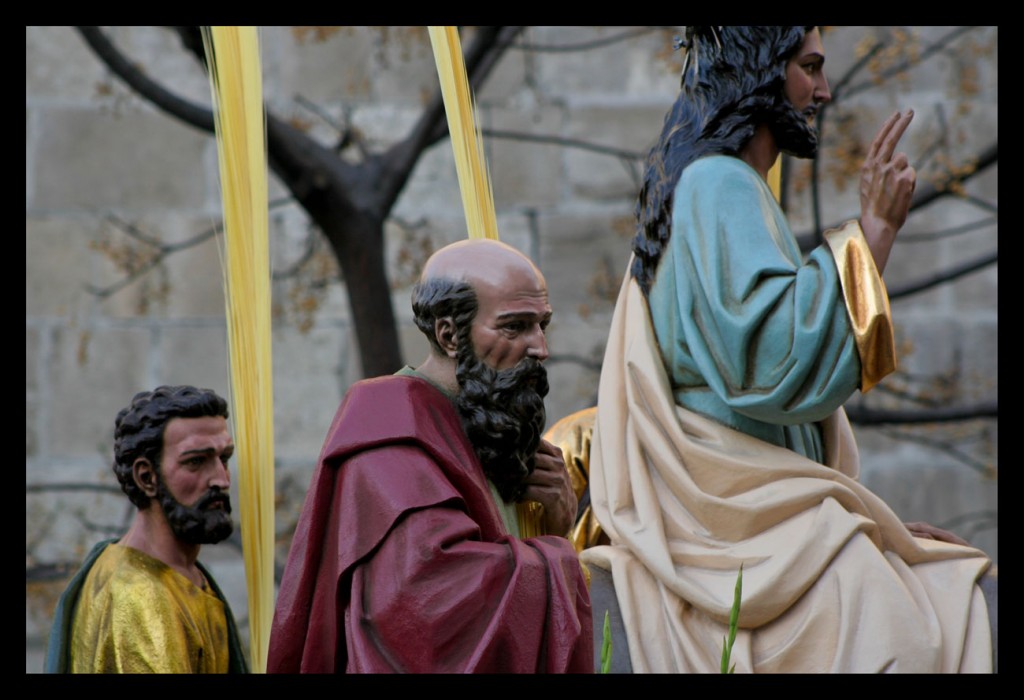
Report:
267,376,594,672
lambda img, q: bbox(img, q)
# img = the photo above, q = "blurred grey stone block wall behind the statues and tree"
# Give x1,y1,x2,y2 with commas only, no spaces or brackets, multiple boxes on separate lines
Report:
26,27,997,671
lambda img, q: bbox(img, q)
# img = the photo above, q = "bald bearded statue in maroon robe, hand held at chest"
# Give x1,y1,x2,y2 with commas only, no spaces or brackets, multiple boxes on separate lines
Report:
268,240,593,673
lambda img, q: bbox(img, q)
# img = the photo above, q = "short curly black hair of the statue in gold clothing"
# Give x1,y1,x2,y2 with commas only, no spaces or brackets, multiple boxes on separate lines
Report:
114,386,227,509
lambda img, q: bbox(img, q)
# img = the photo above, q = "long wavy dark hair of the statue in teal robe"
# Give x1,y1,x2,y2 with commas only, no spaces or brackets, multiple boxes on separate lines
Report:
632,27,813,296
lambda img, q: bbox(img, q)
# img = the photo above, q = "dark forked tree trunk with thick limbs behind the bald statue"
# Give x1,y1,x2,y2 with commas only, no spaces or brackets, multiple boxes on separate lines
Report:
74,27,522,376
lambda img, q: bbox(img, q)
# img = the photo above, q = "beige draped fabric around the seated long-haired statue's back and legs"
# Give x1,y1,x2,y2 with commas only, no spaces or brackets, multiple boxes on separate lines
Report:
582,274,991,672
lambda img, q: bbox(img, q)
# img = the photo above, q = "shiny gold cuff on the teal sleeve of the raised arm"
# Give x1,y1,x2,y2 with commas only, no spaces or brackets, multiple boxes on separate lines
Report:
824,220,896,392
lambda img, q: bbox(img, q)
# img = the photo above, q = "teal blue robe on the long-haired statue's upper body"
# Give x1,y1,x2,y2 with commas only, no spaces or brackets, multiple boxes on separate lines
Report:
648,156,860,463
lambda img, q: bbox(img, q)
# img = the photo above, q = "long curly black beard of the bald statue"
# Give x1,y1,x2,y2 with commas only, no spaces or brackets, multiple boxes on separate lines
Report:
456,342,548,504
